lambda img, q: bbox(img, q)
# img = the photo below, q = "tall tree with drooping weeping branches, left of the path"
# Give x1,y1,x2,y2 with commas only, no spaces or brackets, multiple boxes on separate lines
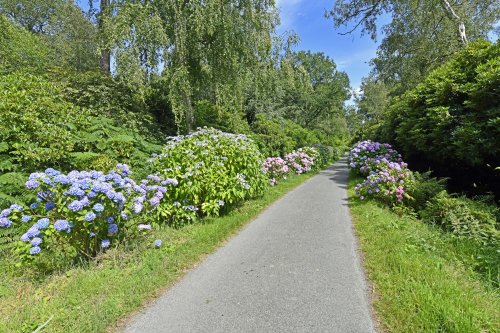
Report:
107,0,276,131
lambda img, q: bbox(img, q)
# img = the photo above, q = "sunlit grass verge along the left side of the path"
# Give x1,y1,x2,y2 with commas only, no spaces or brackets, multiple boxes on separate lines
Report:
0,174,313,333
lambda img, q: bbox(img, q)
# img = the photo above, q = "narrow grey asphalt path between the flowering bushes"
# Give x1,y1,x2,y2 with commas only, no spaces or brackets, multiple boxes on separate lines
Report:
124,160,374,333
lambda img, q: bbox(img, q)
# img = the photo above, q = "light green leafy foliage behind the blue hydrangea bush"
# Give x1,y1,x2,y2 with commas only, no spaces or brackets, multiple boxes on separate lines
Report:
0,73,160,202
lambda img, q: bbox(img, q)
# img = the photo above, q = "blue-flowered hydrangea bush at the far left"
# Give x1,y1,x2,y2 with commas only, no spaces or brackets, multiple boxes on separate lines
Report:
0,164,177,258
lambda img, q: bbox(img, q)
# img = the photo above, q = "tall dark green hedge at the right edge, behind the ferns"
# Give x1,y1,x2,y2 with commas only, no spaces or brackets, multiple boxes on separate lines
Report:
376,41,500,195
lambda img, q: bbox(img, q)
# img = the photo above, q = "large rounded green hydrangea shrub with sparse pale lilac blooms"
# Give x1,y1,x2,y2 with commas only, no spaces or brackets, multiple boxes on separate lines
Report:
151,128,268,224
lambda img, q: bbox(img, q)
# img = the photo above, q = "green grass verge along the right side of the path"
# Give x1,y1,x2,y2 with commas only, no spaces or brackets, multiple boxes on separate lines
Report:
349,177,500,333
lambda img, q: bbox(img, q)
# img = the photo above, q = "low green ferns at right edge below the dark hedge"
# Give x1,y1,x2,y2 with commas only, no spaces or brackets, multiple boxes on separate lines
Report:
420,191,499,242
